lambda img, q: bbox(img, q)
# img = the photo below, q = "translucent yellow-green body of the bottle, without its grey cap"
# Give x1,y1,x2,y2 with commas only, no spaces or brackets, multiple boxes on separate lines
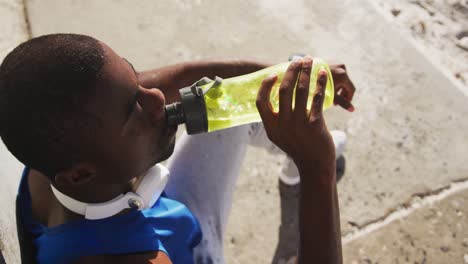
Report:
202,58,334,132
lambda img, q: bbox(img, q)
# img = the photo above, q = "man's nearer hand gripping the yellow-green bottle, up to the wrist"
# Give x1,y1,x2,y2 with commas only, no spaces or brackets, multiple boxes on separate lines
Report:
257,57,335,179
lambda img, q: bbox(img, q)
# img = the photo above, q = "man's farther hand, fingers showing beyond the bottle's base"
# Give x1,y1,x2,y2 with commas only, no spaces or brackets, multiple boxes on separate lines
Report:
330,64,356,112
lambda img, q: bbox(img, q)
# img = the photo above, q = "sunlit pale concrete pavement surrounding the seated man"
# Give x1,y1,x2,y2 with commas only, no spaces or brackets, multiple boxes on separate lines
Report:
0,0,468,263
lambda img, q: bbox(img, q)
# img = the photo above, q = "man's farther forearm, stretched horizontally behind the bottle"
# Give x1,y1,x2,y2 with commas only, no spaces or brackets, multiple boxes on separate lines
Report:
138,60,270,103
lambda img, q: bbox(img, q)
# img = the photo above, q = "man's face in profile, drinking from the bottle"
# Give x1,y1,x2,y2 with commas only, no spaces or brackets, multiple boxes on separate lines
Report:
87,43,177,183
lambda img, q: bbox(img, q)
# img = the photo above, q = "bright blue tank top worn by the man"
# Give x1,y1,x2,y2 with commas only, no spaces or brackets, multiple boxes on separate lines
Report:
18,167,202,264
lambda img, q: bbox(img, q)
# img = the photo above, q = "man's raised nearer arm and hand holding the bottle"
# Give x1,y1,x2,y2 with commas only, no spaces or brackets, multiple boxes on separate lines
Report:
257,57,342,263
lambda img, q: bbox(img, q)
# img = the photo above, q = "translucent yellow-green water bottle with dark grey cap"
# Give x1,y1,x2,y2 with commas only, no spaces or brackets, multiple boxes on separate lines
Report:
165,58,334,134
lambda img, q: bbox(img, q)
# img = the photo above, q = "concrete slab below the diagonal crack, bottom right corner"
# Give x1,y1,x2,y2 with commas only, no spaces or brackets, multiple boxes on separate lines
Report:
344,190,468,264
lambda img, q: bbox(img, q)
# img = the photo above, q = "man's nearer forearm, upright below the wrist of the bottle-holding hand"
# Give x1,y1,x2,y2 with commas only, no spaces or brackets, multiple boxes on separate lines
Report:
298,169,342,263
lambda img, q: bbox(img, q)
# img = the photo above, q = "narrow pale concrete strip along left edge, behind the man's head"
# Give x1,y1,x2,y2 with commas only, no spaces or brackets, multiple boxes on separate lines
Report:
0,0,28,263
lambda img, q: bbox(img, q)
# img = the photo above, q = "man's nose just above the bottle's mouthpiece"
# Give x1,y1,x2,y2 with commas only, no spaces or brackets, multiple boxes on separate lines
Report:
138,87,166,123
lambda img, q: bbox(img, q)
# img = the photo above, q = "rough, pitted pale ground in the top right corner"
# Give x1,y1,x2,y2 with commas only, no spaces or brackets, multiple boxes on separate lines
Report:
375,0,468,85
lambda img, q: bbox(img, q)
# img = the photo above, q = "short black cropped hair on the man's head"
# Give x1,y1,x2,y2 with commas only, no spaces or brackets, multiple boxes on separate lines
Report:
0,34,105,179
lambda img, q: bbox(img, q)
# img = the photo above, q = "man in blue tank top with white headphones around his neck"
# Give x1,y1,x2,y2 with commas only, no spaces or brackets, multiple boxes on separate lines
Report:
0,34,354,263
